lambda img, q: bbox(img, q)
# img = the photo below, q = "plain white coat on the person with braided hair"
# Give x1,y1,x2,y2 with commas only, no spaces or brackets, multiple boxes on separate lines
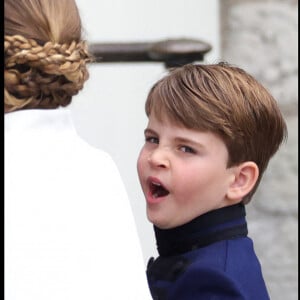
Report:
4,108,151,300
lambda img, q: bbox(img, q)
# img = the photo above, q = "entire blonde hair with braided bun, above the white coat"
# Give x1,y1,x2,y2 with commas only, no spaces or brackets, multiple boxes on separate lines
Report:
4,0,92,112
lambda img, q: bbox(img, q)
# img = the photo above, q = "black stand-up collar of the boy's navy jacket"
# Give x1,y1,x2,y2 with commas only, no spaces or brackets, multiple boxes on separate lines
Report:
154,203,248,256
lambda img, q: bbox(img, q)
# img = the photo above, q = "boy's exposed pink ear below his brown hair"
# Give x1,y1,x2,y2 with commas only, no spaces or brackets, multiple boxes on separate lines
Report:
226,161,259,204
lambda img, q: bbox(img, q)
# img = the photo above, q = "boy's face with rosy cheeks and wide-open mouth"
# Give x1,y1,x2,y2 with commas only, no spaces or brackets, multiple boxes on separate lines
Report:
137,115,238,229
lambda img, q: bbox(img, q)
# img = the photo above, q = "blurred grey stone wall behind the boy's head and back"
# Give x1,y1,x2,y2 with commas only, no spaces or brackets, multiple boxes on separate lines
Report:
220,0,298,300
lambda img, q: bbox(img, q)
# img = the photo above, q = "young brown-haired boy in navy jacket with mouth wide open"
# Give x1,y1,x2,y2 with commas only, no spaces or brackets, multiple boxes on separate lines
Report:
137,63,287,300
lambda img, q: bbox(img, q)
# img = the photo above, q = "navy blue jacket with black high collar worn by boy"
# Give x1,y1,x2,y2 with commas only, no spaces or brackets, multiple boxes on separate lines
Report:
147,204,270,300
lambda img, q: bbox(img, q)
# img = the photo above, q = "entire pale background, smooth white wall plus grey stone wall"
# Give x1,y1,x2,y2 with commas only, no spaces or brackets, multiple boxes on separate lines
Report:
71,0,298,300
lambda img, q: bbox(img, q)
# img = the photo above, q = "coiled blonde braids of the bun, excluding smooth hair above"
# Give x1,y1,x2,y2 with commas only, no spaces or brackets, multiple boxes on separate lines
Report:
4,35,92,111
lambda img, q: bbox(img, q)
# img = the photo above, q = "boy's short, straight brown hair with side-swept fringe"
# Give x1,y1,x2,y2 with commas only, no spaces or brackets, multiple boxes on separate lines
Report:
145,62,287,204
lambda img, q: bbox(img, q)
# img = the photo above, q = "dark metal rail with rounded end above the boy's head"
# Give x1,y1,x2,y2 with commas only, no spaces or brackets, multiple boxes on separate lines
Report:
90,38,212,68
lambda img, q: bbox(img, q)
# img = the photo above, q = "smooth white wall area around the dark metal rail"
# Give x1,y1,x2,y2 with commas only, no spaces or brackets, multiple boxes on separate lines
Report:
71,0,220,264
